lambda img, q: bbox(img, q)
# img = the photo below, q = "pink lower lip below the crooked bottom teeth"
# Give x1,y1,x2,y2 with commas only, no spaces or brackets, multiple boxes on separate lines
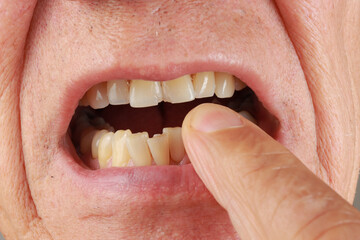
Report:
55,135,208,195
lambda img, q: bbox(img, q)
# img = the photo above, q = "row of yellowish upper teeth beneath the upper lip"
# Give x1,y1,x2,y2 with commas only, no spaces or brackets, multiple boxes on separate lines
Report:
80,72,246,109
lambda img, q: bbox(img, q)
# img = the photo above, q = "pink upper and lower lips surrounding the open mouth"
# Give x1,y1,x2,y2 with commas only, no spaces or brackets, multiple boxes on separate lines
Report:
56,57,296,195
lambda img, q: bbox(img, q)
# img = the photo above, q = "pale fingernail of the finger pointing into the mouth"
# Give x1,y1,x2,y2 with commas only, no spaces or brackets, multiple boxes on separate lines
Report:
191,104,243,132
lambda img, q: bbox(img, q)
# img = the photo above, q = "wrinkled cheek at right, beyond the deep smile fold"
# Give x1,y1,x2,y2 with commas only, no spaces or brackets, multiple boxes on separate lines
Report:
276,0,360,201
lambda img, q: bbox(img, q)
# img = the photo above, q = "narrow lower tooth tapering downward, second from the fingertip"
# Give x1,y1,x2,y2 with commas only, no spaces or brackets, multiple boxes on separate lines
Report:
147,134,170,165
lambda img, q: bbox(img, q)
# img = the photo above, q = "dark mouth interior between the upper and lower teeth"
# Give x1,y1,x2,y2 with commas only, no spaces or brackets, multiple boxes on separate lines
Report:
70,87,278,168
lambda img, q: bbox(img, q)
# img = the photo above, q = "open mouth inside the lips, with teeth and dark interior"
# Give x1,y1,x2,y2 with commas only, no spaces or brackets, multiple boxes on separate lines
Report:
68,72,278,170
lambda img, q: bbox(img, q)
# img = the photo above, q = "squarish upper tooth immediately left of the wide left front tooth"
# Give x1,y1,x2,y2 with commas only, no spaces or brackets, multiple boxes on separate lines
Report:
107,80,130,105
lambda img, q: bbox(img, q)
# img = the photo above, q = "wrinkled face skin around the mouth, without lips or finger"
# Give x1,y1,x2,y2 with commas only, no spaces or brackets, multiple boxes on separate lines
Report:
0,0,360,239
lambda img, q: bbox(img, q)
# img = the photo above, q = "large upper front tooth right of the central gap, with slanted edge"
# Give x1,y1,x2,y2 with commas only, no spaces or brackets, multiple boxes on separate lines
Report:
162,75,195,103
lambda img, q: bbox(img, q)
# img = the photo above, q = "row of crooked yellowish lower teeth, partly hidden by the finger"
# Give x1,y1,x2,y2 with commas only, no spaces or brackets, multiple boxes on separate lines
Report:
72,115,255,168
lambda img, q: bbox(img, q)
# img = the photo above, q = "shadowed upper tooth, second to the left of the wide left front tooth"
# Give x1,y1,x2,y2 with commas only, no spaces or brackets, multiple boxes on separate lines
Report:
86,82,109,109
